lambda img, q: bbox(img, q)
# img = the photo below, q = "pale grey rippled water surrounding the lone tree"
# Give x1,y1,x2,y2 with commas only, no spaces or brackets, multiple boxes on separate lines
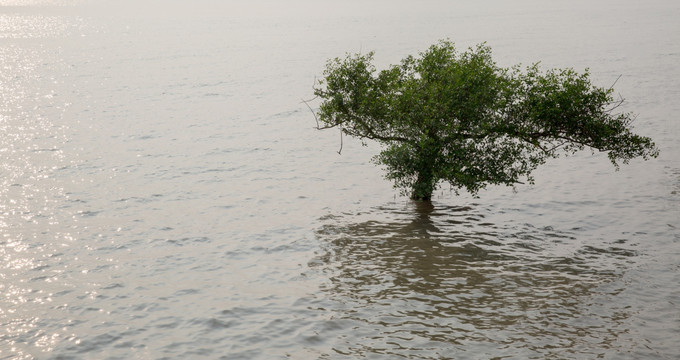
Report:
0,0,680,359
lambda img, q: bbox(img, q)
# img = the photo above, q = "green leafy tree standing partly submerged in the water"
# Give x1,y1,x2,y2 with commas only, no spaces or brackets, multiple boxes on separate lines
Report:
314,41,659,200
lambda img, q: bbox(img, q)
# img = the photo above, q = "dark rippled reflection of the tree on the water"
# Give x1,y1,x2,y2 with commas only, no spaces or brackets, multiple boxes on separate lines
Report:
310,203,634,358
